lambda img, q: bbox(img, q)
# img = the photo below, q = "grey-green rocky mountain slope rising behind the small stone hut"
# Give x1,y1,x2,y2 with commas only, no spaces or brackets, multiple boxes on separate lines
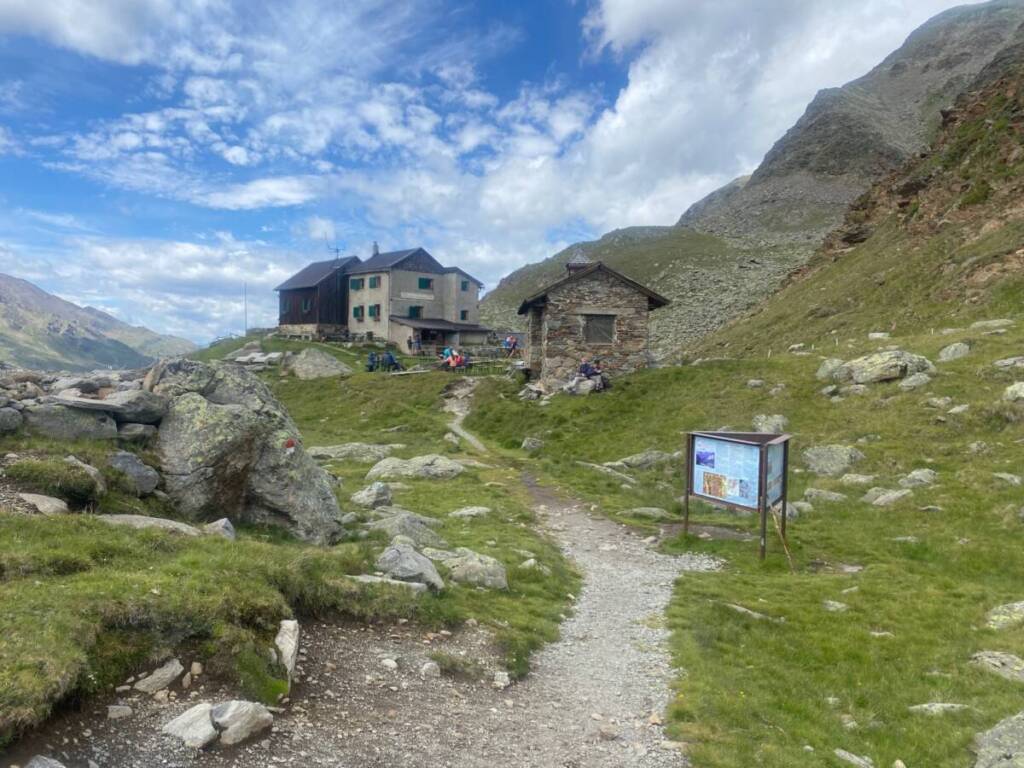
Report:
481,0,1024,352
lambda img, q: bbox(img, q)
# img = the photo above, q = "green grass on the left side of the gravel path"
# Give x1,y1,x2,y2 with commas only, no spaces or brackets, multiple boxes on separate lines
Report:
0,372,579,745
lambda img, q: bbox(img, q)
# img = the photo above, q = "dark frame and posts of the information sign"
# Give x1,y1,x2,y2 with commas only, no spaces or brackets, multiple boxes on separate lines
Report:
683,432,792,560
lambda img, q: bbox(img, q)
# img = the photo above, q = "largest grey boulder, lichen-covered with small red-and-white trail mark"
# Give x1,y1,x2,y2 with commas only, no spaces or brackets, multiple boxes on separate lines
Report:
145,360,342,544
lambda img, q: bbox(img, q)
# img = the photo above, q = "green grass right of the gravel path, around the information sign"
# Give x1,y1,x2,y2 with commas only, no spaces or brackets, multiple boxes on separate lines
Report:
467,321,1024,768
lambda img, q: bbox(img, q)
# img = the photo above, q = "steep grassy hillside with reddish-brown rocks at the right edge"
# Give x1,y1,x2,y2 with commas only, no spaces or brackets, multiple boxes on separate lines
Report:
697,18,1024,356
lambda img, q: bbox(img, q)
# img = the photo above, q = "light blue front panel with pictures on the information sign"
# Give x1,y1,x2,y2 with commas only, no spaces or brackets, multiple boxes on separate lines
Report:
691,435,761,509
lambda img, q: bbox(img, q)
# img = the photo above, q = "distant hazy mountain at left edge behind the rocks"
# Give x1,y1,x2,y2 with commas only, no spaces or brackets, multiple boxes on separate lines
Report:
0,274,196,371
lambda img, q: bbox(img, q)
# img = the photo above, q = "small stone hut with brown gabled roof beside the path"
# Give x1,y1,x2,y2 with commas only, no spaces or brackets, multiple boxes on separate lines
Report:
519,255,669,381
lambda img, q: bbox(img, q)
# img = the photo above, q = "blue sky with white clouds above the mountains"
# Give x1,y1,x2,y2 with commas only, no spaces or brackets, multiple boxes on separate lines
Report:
0,0,978,343
